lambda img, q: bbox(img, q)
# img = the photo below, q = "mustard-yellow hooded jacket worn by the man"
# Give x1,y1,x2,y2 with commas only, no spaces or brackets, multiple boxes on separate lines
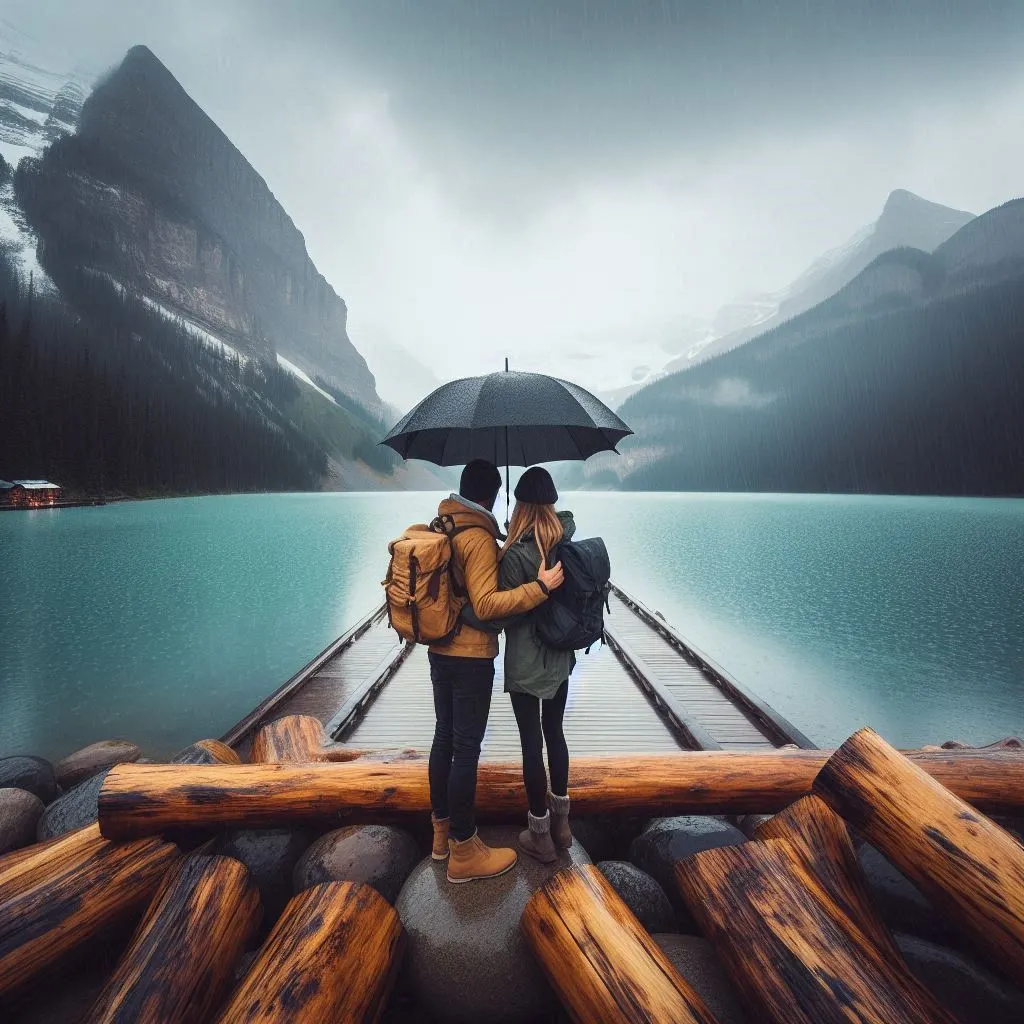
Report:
430,497,548,658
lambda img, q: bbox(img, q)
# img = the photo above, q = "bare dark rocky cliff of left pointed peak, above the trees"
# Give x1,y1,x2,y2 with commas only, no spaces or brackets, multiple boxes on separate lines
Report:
19,46,380,411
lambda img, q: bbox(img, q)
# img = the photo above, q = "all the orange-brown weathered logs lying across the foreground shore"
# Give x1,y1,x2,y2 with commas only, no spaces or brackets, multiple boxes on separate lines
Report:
0,717,1024,1024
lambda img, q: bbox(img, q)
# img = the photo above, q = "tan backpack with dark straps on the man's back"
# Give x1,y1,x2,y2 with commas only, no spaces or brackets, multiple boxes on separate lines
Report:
383,515,483,644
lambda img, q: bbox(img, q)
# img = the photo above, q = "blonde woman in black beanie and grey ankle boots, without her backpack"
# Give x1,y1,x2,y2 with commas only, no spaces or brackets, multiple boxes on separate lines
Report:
499,466,575,863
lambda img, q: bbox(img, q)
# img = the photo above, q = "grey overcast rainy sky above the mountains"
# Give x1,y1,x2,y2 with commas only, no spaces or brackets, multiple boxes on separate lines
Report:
3,0,1024,397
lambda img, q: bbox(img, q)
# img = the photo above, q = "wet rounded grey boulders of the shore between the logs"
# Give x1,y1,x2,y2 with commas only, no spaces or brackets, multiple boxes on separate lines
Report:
0,738,1024,1024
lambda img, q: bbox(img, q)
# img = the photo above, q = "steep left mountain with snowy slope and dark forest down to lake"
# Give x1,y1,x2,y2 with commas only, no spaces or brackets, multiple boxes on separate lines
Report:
0,41,448,495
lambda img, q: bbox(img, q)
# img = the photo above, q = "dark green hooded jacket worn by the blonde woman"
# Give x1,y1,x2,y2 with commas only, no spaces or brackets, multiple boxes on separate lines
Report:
498,512,575,700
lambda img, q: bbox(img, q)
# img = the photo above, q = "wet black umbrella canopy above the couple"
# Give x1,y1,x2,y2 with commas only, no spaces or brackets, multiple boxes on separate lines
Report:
381,370,633,466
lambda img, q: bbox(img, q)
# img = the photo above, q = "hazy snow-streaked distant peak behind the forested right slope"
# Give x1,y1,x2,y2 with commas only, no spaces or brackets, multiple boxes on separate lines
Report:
635,188,974,390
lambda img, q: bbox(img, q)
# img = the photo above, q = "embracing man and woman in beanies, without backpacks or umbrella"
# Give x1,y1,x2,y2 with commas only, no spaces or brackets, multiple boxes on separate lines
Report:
429,460,575,882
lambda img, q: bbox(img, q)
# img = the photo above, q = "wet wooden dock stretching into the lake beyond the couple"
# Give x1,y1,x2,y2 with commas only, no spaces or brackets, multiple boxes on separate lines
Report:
222,585,814,761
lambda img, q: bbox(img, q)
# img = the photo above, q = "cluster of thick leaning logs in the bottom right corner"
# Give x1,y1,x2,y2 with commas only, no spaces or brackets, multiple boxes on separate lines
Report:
676,729,1024,1024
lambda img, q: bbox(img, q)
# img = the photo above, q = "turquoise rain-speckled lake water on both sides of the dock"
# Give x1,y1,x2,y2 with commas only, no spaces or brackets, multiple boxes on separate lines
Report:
0,494,1024,758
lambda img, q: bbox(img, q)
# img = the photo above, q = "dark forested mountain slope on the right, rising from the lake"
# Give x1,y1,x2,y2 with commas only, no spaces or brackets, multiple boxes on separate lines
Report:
610,200,1024,495
